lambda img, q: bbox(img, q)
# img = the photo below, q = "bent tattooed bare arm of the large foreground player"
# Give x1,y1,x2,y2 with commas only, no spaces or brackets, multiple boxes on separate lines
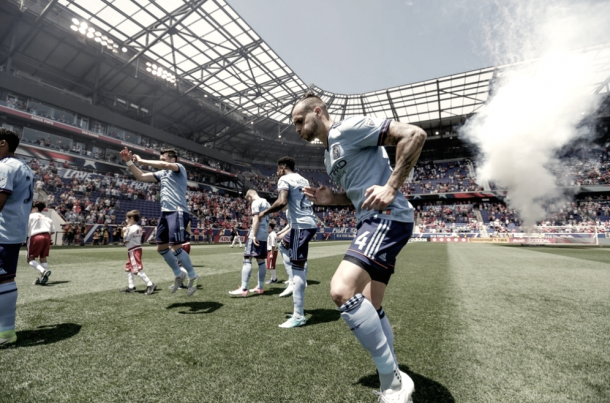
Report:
362,122,427,210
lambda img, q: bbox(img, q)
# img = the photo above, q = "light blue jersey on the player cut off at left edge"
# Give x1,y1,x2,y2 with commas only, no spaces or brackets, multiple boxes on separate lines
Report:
0,157,34,244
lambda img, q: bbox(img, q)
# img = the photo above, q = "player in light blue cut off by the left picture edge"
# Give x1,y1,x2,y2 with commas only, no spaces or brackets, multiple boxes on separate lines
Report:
0,128,34,346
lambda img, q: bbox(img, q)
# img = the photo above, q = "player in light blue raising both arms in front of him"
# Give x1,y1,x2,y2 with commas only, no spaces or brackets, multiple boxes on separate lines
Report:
121,147,199,296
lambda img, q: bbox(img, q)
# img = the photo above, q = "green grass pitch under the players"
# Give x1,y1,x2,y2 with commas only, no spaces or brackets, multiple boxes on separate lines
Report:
0,242,610,403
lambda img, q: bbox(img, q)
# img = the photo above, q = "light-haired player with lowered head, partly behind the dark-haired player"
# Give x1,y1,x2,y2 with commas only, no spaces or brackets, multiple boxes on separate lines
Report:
229,189,269,297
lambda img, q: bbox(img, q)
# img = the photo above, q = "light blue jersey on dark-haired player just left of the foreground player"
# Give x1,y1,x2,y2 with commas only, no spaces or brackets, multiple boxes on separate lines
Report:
277,173,318,229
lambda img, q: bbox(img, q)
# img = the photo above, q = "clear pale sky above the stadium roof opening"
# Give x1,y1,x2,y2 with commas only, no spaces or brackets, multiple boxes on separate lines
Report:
227,0,502,94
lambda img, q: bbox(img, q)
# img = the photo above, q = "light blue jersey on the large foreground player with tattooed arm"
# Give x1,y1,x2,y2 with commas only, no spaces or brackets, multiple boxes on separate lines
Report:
324,116,413,222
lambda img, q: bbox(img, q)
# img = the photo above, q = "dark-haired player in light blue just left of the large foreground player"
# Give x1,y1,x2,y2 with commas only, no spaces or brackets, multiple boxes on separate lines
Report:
259,157,318,328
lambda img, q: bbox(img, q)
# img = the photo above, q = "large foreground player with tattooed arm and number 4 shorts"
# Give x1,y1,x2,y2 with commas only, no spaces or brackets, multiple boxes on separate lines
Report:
292,93,426,402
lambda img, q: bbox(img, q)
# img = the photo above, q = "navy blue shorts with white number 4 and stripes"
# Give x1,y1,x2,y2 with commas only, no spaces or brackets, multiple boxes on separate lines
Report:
343,217,413,284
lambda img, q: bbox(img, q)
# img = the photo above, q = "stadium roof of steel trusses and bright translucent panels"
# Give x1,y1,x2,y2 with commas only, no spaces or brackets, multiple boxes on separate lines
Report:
0,0,610,166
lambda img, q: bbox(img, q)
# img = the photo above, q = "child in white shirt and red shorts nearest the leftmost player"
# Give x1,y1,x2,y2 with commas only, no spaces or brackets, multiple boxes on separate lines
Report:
27,201,55,285
